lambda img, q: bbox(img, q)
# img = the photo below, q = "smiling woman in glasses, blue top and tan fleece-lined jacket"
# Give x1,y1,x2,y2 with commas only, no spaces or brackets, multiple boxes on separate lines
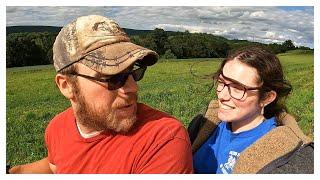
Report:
188,47,313,173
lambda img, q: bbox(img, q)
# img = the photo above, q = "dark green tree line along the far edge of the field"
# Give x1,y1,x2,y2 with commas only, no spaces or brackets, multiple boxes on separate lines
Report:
6,28,310,68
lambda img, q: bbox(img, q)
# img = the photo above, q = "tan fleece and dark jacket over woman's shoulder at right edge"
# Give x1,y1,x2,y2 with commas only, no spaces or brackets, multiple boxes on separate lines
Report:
234,114,313,173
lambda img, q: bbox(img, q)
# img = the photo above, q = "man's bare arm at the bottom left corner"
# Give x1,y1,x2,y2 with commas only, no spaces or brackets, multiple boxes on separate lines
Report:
9,157,55,174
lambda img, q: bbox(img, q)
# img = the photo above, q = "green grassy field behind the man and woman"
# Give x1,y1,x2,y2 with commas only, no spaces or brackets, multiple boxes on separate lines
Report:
6,53,314,165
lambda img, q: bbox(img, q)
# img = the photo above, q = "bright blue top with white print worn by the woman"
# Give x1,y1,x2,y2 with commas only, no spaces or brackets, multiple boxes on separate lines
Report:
193,117,277,174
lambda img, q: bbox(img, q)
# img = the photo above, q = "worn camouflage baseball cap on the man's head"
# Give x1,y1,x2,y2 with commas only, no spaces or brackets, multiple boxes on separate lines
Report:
53,15,159,75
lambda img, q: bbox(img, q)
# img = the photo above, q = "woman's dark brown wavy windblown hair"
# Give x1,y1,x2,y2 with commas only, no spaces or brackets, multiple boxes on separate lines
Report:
213,46,292,118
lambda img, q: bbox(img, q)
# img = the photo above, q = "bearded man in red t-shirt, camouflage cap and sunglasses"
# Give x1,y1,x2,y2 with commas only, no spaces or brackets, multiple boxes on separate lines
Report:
9,15,193,173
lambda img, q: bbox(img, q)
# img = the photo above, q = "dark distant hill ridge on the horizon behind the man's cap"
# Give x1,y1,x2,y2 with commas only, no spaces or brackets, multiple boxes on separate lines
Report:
6,26,152,36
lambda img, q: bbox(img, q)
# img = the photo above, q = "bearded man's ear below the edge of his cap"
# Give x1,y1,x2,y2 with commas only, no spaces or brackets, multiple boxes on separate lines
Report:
55,73,74,99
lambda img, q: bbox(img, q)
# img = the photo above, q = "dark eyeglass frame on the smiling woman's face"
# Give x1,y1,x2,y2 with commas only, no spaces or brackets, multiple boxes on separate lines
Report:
215,73,263,100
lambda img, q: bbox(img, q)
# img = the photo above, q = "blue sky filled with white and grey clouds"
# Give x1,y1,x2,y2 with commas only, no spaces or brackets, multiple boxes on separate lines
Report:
6,6,314,48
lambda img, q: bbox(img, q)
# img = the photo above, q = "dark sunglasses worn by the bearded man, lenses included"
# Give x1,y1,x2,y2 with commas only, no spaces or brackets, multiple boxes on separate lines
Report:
70,65,147,90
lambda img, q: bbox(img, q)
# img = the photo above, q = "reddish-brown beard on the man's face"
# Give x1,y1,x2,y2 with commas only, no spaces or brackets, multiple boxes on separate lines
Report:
75,83,137,133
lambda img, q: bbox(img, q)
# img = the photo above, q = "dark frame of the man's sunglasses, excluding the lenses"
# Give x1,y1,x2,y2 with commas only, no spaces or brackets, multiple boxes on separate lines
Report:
69,63,147,90
